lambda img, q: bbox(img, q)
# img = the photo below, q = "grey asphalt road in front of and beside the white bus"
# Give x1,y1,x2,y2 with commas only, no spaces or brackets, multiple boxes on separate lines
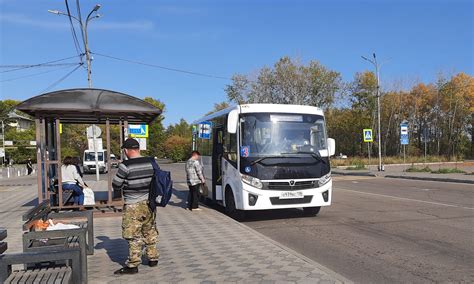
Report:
245,177,474,283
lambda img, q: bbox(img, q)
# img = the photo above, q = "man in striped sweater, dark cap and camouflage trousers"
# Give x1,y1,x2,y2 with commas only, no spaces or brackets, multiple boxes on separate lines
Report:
112,138,159,274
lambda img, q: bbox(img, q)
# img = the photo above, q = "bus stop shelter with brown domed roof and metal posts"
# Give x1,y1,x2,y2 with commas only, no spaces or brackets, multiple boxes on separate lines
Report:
17,88,161,209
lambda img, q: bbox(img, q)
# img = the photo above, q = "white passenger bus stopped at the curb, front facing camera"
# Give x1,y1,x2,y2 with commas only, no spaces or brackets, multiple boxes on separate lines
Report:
193,104,335,218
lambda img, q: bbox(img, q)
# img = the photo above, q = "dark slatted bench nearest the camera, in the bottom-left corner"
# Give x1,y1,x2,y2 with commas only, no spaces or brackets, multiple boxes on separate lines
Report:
0,228,83,284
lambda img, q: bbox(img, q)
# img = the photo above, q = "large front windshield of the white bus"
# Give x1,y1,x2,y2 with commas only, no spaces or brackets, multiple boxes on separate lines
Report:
241,113,327,157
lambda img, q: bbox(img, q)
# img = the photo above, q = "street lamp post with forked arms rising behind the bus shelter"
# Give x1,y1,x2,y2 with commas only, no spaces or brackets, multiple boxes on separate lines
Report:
48,4,101,181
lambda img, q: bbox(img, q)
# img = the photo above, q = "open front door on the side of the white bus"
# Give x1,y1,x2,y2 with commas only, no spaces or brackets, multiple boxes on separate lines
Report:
212,126,224,200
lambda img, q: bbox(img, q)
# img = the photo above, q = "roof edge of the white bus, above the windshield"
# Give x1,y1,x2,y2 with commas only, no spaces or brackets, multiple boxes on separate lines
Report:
193,104,324,124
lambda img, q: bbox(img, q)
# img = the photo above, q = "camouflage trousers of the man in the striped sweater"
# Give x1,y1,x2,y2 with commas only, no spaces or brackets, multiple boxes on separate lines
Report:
122,201,159,267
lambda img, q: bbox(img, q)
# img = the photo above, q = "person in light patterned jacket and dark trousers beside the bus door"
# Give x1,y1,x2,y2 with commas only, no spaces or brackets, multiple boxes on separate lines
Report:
186,151,206,211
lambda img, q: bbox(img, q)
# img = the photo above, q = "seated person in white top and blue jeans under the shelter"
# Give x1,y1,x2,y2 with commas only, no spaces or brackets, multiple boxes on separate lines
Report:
60,156,86,207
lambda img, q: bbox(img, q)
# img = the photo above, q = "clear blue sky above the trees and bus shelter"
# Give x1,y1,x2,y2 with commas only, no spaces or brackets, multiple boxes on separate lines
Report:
0,0,474,125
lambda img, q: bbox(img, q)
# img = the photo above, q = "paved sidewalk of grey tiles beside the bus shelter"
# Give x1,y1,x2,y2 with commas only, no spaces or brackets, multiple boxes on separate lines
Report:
0,178,350,283
